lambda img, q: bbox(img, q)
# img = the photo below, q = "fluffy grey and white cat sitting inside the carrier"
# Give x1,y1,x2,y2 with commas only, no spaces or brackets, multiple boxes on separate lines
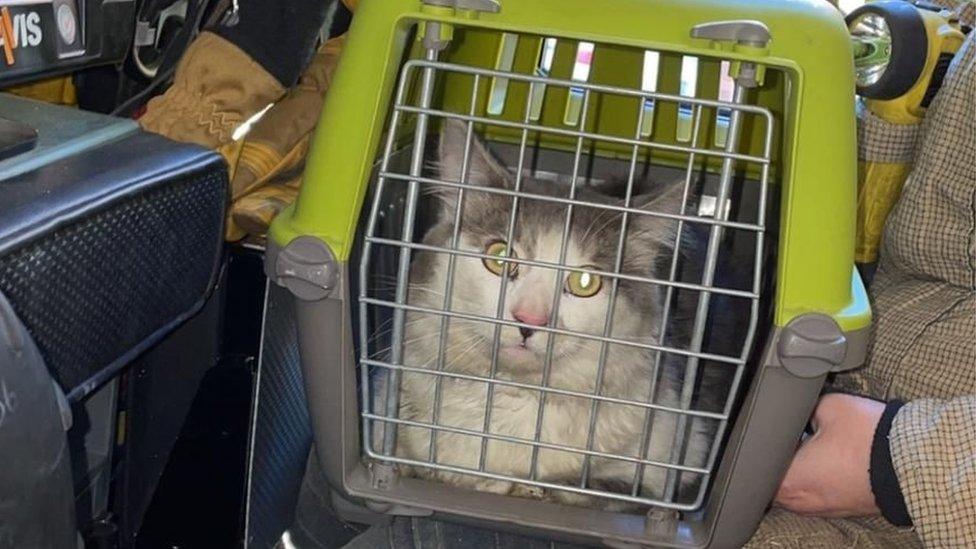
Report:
378,121,720,510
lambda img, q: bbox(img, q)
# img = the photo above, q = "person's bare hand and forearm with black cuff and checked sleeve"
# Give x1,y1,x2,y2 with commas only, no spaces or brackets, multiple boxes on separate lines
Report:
775,393,976,547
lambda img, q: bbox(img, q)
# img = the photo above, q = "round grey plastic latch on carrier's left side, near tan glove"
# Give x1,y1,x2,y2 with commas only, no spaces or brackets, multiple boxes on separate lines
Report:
272,235,339,301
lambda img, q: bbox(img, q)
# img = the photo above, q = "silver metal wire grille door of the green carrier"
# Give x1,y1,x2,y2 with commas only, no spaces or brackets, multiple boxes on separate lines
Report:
359,52,773,510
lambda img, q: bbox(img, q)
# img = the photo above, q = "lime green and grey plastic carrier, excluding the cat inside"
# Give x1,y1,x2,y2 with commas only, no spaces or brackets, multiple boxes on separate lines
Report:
266,0,871,547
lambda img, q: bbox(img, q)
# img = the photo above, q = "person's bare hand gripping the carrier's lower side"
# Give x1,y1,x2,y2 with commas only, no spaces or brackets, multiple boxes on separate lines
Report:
773,393,885,517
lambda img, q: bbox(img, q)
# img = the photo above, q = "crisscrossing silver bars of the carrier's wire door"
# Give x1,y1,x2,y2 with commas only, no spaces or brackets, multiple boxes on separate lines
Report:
360,56,773,510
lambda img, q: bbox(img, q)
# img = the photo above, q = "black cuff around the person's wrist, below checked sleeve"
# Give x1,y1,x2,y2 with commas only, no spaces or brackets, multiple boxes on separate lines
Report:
870,400,912,526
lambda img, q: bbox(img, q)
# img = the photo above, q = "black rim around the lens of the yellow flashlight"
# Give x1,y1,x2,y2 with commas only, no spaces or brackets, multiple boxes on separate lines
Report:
846,0,929,99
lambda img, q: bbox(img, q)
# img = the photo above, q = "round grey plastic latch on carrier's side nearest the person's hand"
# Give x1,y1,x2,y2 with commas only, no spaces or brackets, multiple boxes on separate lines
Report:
776,314,847,378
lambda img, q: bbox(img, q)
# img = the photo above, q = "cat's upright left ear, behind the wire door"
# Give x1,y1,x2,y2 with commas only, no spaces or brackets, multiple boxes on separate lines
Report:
437,119,508,188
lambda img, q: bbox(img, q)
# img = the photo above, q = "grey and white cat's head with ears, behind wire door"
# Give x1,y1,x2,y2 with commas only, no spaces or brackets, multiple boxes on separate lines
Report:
411,123,681,370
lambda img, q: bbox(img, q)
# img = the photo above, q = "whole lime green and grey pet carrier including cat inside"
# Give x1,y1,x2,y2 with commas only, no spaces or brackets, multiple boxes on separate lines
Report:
266,0,870,547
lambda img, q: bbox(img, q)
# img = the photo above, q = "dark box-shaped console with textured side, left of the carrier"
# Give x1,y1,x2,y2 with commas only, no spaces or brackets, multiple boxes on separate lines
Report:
0,97,227,400
